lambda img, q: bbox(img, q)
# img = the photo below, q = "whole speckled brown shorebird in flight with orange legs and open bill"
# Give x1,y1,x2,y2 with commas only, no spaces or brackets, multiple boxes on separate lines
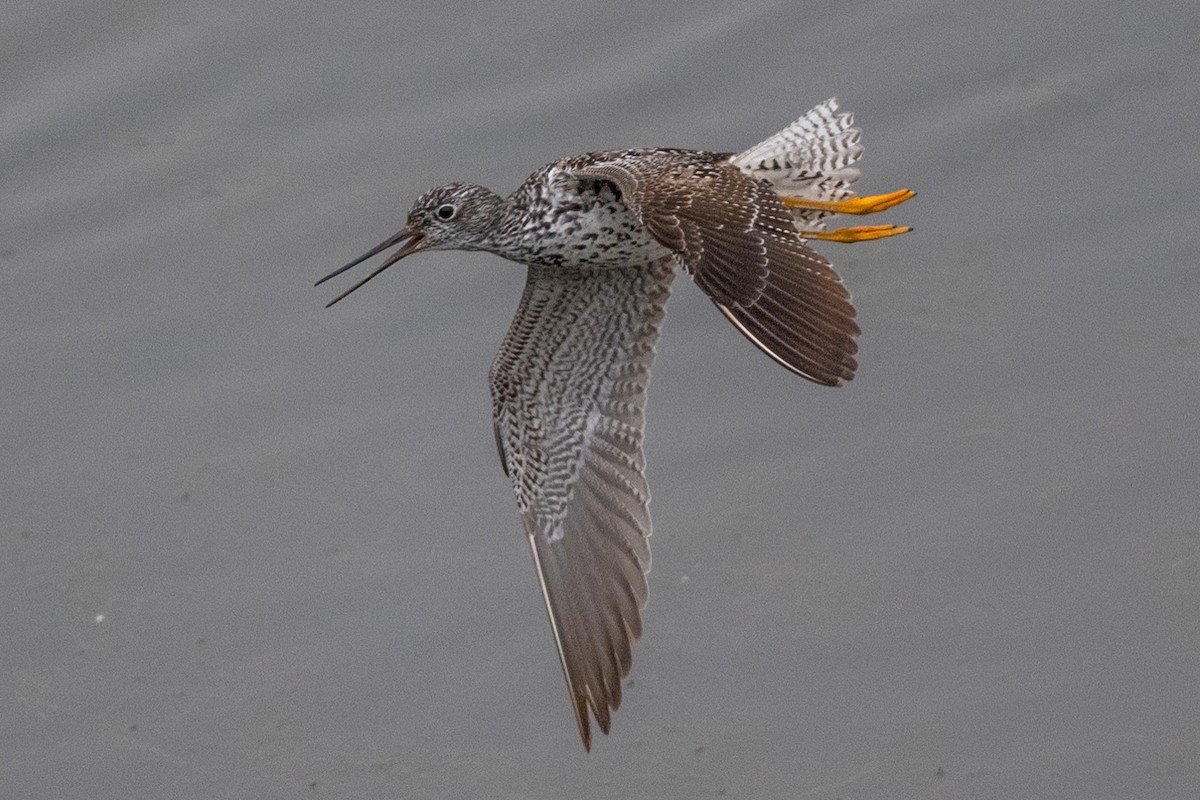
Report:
317,100,913,750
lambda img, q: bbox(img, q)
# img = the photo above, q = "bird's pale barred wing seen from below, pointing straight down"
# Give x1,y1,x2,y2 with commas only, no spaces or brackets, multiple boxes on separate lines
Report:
490,258,676,747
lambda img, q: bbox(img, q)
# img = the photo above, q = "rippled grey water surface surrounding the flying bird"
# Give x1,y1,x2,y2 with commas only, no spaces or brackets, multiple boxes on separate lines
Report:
0,0,1200,800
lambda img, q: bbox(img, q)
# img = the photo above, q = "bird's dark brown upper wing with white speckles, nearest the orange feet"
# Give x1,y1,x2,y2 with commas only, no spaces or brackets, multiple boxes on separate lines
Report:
564,150,859,386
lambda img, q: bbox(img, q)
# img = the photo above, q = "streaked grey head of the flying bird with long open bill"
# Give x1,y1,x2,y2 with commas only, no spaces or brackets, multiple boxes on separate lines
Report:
317,184,505,308
